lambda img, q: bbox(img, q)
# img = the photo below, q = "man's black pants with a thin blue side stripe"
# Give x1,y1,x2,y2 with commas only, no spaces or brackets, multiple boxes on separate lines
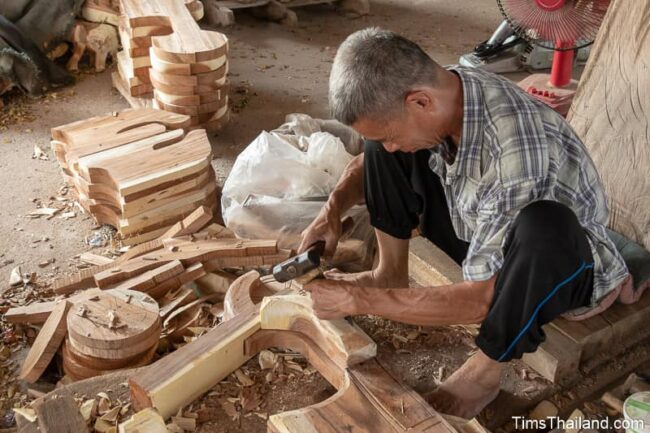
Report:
364,141,593,361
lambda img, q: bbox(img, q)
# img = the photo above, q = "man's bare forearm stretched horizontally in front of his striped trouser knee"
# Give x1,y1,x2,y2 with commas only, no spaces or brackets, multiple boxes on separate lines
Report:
351,280,494,326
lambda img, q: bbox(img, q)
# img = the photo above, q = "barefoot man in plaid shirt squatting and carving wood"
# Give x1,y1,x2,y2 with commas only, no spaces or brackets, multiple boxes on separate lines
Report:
300,28,627,418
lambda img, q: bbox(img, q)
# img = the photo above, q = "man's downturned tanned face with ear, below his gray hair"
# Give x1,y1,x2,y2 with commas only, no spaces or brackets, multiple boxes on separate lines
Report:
352,89,449,152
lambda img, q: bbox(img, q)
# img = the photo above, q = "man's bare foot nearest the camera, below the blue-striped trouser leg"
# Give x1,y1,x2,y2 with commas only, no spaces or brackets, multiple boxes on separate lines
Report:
426,350,503,419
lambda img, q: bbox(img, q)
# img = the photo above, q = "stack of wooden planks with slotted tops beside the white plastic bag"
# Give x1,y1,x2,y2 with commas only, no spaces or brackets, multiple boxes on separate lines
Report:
52,109,218,245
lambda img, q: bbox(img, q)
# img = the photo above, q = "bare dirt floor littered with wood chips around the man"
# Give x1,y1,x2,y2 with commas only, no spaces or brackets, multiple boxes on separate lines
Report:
0,0,560,433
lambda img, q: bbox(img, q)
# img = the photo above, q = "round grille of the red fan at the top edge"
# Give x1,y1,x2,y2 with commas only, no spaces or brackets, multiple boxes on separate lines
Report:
497,0,610,51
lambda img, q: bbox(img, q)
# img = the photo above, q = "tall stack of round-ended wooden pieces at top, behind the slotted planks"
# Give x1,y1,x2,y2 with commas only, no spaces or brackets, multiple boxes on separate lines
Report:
113,0,229,131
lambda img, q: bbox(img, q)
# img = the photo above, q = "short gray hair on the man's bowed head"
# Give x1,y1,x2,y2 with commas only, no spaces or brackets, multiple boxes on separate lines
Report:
329,27,440,125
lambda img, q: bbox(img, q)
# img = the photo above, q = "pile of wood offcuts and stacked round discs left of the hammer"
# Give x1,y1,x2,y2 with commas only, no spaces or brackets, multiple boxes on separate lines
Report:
5,207,290,382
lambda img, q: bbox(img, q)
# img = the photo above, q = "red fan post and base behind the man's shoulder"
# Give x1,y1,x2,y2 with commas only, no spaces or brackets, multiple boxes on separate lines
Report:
519,41,578,117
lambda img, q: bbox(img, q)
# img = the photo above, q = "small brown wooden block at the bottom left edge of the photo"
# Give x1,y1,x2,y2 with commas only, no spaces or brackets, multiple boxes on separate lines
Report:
32,393,88,433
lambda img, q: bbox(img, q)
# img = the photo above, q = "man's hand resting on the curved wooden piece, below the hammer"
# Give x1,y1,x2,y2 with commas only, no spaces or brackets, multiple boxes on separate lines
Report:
305,280,358,320
